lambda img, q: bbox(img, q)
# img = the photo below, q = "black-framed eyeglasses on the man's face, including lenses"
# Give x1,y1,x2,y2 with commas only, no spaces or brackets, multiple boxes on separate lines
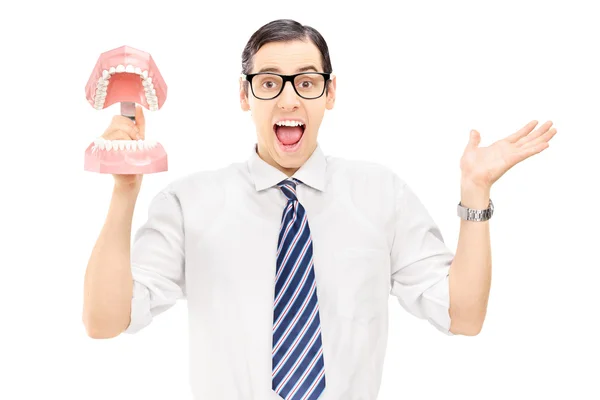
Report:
242,72,331,100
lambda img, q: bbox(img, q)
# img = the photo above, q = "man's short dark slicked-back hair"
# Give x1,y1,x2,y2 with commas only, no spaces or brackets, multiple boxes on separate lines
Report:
242,19,333,95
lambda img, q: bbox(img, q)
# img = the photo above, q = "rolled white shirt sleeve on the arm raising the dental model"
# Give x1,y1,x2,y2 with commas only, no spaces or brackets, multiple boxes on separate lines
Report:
124,189,186,334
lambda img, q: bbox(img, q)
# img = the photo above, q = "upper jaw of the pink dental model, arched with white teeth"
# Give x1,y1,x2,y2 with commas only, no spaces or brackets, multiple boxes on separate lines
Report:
85,46,167,111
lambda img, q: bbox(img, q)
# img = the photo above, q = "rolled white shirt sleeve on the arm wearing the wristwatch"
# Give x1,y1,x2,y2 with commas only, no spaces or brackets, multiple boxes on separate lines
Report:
391,176,454,336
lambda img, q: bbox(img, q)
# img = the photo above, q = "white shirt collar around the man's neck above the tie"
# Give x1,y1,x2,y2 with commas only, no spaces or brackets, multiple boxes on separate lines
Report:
248,143,327,191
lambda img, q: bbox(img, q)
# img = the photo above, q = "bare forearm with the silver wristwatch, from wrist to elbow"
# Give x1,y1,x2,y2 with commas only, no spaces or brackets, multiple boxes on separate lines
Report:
449,181,492,335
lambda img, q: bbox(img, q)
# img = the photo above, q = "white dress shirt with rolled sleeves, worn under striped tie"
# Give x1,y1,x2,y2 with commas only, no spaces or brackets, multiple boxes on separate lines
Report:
126,145,454,400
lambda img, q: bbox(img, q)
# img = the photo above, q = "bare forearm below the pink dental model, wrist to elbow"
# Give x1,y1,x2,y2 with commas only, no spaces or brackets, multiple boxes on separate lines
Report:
83,188,137,338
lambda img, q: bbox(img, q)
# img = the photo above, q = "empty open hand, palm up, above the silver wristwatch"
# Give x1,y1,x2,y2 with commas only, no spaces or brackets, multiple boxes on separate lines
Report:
460,120,557,188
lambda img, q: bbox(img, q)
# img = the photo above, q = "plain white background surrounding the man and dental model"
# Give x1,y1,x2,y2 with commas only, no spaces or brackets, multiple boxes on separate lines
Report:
0,0,600,400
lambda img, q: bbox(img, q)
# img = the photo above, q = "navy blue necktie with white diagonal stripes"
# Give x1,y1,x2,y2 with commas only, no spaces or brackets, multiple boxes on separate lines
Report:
272,179,325,400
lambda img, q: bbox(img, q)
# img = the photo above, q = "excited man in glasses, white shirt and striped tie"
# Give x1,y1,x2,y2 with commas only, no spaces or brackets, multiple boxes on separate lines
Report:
84,20,556,400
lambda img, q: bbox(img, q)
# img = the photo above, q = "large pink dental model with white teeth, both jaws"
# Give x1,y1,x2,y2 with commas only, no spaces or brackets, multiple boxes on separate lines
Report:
84,46,168,175
